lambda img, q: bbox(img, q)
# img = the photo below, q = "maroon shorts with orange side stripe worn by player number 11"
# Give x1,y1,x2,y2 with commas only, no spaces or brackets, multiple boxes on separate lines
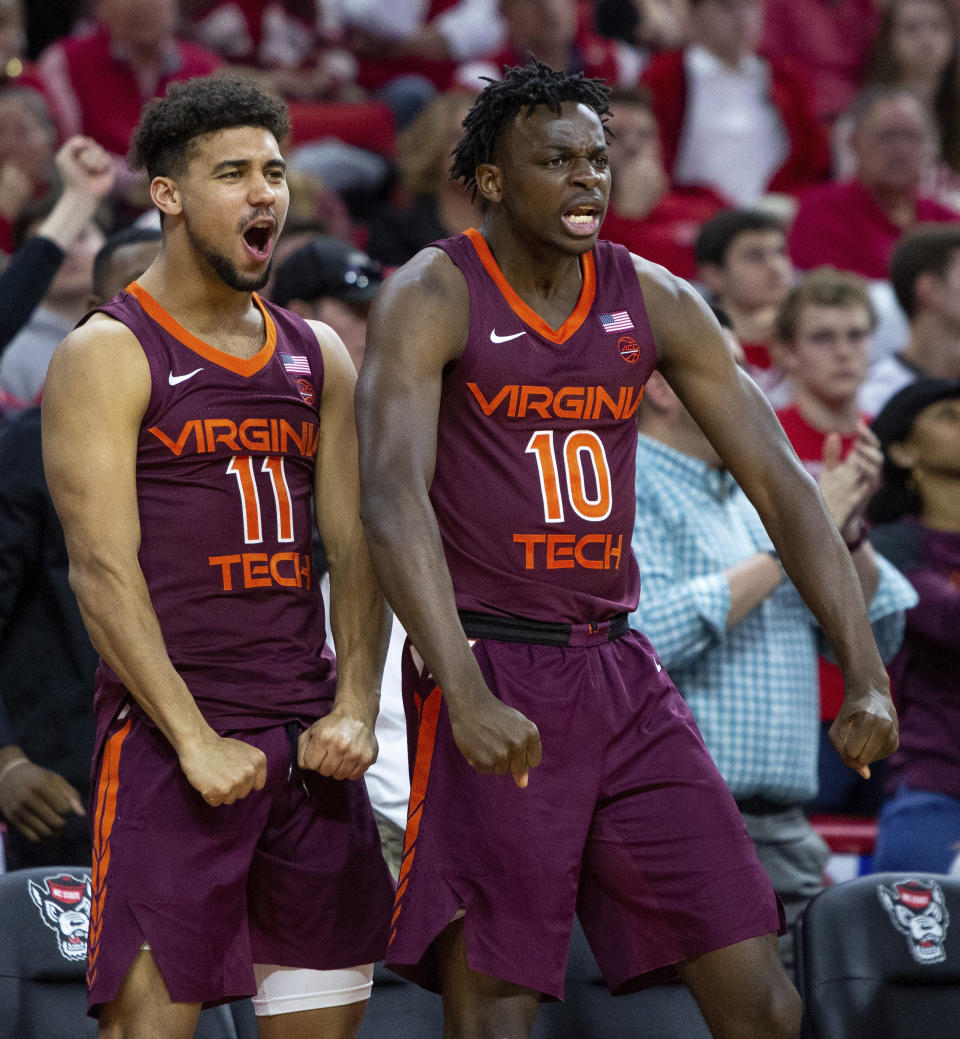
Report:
87,708,394,1014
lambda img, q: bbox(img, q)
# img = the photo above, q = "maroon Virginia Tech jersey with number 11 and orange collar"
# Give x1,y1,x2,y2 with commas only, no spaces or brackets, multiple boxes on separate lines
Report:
89,283,335,728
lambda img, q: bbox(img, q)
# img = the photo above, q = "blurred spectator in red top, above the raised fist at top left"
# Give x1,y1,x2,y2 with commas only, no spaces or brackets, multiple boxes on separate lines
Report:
38,0,222,190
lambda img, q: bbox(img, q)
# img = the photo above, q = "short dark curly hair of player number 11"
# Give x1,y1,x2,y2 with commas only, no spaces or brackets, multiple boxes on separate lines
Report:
130,76,290,180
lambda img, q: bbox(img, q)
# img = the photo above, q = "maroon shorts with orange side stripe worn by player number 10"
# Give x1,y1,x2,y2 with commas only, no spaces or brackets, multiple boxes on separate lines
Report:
386,625,782,997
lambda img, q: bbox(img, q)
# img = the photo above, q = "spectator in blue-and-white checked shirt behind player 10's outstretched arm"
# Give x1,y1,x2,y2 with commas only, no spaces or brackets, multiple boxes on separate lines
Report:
631,317,916,967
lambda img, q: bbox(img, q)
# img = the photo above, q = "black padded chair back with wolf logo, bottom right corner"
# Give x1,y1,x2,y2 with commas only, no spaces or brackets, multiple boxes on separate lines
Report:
797,873,960,1039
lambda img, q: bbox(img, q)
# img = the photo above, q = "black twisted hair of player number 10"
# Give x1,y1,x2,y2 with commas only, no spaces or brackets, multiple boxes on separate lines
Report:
450,58,610,197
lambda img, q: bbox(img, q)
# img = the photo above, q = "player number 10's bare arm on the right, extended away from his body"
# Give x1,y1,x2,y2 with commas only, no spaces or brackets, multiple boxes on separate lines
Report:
635,258,898,776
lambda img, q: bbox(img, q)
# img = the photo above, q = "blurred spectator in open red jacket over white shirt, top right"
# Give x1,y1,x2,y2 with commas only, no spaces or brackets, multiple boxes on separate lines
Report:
643,0,829,206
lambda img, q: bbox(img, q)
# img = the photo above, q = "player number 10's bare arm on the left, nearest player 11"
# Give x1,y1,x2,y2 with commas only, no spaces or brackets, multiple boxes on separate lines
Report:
356,248,540,787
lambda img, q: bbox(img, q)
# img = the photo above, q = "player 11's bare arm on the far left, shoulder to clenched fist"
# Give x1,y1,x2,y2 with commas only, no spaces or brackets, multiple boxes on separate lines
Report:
43,316,266,804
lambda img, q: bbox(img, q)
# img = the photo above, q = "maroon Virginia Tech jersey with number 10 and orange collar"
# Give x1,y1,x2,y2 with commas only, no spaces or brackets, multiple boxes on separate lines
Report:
430,229,657,623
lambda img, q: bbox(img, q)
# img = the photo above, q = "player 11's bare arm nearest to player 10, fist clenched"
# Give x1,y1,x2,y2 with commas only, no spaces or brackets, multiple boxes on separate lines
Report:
299,321,390,779
